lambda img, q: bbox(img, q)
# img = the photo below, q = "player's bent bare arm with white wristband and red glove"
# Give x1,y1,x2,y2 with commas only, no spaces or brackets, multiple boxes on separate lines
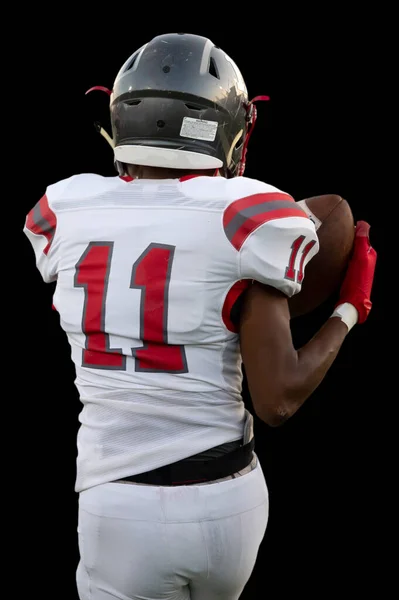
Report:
240,222,376,426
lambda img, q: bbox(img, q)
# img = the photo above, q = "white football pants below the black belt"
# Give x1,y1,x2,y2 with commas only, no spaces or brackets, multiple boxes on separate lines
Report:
77,459,269,600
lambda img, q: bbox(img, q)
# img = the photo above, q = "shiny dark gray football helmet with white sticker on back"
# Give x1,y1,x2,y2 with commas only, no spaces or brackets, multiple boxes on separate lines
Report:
110,33,249,175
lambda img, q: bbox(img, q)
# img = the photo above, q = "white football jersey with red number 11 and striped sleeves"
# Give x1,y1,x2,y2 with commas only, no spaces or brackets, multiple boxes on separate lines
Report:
24,174,319,492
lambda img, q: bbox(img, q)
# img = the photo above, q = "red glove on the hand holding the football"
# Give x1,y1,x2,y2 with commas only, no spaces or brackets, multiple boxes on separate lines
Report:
337,221,377,323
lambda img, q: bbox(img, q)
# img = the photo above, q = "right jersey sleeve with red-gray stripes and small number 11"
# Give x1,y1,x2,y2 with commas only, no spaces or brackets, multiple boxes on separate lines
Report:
223,182,319,297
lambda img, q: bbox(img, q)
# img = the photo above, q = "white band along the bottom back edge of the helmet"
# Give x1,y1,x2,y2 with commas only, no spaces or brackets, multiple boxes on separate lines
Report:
114,145,223,169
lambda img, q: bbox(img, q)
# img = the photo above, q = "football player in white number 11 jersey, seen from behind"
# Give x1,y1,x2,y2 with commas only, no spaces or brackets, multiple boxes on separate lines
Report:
24,34,376,600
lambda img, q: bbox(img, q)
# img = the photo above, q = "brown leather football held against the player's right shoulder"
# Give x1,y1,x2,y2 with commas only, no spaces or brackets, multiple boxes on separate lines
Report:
289,194,355,318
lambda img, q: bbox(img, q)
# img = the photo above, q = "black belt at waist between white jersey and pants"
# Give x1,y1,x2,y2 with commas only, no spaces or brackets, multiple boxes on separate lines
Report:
118,438,255,485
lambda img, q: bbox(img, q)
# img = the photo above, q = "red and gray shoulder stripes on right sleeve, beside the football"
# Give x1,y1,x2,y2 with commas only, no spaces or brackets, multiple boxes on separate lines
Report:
223,192,308,250
